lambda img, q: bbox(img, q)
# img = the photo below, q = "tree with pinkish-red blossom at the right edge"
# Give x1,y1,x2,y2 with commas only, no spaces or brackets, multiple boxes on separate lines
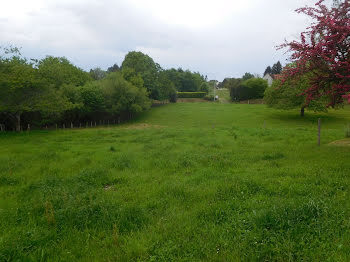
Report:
279,0,350,107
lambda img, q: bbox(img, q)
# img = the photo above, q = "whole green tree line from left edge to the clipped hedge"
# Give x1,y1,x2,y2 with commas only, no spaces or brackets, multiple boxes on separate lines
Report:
0,47,208,131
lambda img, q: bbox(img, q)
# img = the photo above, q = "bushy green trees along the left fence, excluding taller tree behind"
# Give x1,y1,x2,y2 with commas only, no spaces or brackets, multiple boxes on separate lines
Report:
0,49,151,131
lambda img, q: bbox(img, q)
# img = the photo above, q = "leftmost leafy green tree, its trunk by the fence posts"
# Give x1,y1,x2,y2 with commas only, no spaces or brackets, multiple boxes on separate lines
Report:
0,49,76,131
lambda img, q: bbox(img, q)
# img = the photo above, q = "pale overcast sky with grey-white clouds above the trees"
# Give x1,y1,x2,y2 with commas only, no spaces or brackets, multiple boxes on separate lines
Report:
0,0,322,80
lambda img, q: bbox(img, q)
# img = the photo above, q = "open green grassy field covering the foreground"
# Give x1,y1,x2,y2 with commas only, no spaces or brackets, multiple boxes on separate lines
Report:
0,103,350,261
